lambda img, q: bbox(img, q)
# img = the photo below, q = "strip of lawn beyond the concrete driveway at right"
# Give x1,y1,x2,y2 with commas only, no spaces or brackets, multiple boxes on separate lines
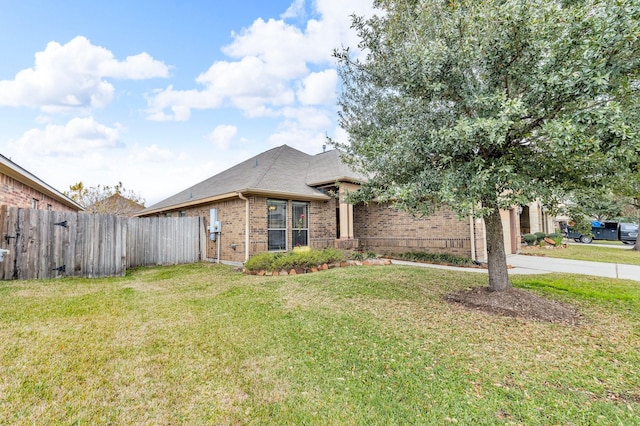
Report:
522,243,640,265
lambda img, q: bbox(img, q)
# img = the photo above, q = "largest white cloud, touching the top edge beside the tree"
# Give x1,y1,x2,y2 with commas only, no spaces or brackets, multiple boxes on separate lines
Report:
147,0,372,121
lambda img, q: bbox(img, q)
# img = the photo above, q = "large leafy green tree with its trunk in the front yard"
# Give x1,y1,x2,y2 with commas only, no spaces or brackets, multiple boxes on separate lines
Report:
335,0,640,290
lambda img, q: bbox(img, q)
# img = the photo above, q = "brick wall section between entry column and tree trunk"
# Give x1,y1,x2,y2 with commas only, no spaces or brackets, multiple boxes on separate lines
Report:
354,203,477,257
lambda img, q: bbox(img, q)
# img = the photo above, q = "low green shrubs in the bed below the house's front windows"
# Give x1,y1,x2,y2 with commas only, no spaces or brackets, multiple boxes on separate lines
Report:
244,248,345,271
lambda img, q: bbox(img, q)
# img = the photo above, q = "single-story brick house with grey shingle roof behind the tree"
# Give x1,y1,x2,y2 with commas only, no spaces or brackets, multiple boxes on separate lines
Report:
136,145,520,262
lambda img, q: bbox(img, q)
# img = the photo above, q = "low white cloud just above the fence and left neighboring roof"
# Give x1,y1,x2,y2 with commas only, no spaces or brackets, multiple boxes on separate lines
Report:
16,117,123,157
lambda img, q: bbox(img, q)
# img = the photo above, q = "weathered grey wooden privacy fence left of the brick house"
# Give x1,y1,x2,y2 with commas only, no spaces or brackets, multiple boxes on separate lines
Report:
0,206,206,280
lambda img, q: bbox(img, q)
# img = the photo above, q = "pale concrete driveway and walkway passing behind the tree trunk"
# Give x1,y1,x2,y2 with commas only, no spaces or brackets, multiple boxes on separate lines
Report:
384,254,640,281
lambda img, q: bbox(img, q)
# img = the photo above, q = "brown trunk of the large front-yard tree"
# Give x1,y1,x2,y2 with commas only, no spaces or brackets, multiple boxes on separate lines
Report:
484,207,511,291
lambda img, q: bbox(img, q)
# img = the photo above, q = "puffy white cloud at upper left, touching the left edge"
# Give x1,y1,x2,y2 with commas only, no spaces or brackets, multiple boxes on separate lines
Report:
0,36,169,112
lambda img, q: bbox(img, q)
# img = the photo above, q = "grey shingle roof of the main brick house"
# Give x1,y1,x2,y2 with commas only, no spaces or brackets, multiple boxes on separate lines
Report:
137,145,362,216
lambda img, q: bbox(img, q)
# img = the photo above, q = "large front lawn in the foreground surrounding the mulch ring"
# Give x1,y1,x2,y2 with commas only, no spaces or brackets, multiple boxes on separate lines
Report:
0,264,640,425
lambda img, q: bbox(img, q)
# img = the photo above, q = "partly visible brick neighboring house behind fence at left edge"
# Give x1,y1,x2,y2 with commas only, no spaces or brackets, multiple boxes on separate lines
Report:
0,155,84,211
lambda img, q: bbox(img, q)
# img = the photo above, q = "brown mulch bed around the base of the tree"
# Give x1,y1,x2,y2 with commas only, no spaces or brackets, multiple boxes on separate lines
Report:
445,287,582,325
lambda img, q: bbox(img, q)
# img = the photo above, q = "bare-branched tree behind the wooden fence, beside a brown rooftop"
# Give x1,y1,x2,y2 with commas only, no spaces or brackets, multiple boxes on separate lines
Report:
65,182,144,216
